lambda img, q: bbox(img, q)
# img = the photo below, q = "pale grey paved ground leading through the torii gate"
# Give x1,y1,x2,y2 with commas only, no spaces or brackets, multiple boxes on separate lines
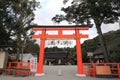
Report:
0,66,120,80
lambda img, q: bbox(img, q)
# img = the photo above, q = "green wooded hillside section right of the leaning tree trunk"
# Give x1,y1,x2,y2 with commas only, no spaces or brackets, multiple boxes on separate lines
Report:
109,30,120,62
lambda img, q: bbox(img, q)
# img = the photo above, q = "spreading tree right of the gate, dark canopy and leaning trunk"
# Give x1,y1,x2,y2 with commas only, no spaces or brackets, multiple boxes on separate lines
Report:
52,0,120,62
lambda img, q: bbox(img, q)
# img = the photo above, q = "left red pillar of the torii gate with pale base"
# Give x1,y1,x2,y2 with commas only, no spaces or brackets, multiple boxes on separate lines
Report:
35,29,46,76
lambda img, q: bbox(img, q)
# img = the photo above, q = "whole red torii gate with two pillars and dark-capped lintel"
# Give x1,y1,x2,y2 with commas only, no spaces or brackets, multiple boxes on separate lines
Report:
32,25,89,76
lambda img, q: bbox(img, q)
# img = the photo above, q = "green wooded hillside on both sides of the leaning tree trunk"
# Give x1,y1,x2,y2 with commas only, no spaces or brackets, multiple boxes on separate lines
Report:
82,30,120,62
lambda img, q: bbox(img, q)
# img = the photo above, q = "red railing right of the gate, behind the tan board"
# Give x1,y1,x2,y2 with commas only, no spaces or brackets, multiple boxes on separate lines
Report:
83,63,120,78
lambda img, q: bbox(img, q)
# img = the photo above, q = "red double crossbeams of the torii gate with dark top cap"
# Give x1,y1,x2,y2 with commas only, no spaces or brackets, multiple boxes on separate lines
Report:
32,25,89,39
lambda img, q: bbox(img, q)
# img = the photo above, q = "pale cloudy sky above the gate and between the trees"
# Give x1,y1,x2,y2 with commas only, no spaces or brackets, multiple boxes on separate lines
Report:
34,0,119,47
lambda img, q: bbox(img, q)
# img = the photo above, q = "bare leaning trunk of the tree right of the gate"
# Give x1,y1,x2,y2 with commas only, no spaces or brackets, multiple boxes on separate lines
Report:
96,25,108,62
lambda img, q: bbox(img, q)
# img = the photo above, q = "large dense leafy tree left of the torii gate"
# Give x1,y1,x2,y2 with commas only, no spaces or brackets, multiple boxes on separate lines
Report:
0,0,39,60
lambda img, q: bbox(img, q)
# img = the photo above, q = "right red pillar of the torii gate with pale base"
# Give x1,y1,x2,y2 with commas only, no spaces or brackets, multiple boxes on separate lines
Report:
75,29,85,77
